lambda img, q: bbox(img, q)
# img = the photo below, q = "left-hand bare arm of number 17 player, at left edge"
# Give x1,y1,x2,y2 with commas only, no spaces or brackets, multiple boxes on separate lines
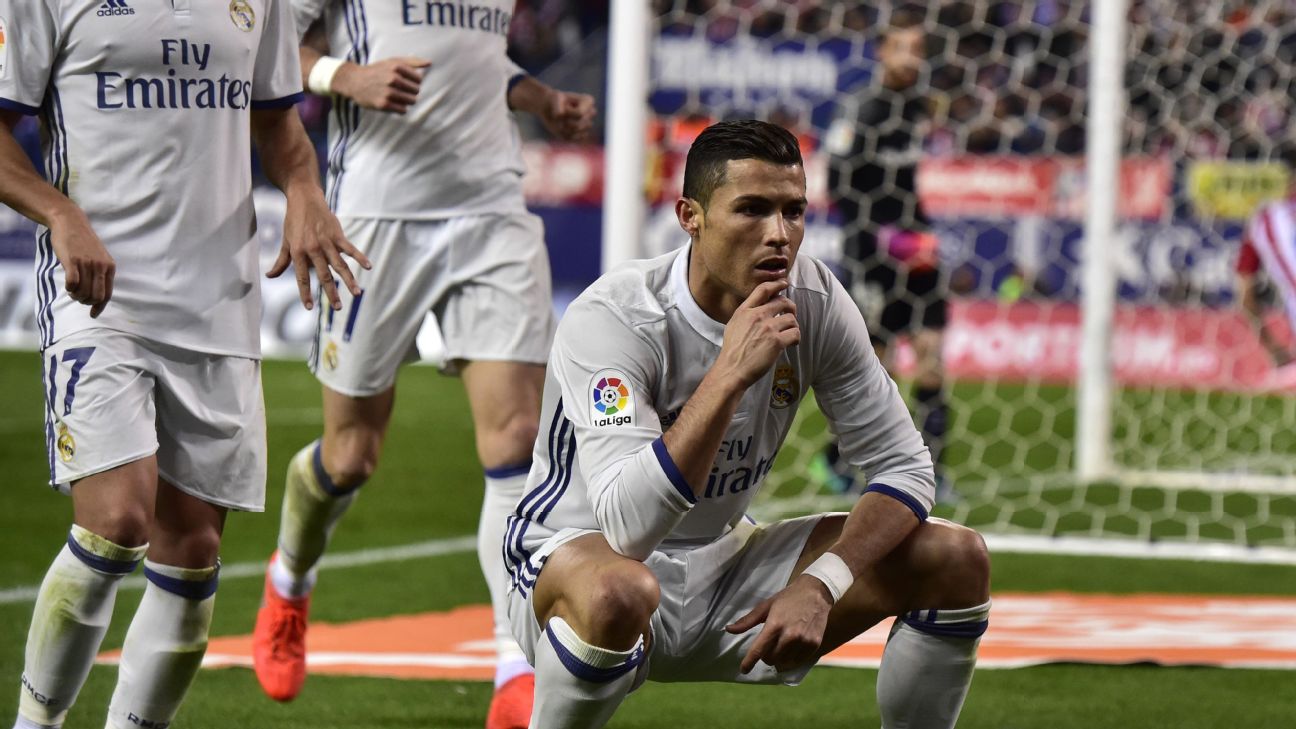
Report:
0,110,117,317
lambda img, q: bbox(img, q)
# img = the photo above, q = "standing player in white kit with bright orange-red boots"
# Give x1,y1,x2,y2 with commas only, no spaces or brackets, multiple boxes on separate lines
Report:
254,0,594,729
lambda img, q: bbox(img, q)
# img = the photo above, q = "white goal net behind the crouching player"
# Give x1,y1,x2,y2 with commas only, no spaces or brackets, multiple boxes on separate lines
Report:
619,0,1296,560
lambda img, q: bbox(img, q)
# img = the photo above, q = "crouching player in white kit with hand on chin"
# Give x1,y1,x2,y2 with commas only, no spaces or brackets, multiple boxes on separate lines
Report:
504,121,990,729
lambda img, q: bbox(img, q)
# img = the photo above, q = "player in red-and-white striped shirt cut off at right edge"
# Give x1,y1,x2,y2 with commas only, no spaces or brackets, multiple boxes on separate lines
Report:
1236,149,1296,370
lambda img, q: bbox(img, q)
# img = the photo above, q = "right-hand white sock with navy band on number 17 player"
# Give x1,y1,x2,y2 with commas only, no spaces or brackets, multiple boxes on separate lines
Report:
108,559,220,729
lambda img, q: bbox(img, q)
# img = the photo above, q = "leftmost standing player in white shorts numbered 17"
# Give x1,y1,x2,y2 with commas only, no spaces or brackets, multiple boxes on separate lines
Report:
0,0,364,729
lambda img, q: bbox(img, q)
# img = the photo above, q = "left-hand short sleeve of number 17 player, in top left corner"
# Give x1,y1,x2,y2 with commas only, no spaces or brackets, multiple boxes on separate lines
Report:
0,0,58,115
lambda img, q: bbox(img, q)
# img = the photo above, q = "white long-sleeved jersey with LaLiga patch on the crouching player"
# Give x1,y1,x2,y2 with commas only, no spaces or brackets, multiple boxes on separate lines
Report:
504,246,936,589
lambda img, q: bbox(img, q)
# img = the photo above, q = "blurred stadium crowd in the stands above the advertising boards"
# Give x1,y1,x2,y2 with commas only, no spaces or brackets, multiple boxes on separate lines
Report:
7,0,1296,166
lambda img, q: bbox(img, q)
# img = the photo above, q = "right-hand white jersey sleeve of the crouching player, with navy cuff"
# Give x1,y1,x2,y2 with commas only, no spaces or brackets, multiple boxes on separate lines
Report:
811,265,936,520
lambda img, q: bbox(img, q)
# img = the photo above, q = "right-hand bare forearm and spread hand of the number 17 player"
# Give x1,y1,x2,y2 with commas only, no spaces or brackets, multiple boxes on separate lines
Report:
251,108,371,309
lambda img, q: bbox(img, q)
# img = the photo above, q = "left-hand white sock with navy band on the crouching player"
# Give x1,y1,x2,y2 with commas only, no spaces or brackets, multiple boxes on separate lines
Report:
530,617,644,729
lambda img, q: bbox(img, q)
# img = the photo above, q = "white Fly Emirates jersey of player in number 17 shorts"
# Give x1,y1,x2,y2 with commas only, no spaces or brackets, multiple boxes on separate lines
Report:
0,0,302,357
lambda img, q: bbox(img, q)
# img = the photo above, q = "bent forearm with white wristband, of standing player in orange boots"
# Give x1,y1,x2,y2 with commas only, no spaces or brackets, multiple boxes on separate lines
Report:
299,23,432,114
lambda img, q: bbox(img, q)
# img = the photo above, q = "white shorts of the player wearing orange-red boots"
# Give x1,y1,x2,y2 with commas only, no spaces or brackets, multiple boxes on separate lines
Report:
308,213,555,397
